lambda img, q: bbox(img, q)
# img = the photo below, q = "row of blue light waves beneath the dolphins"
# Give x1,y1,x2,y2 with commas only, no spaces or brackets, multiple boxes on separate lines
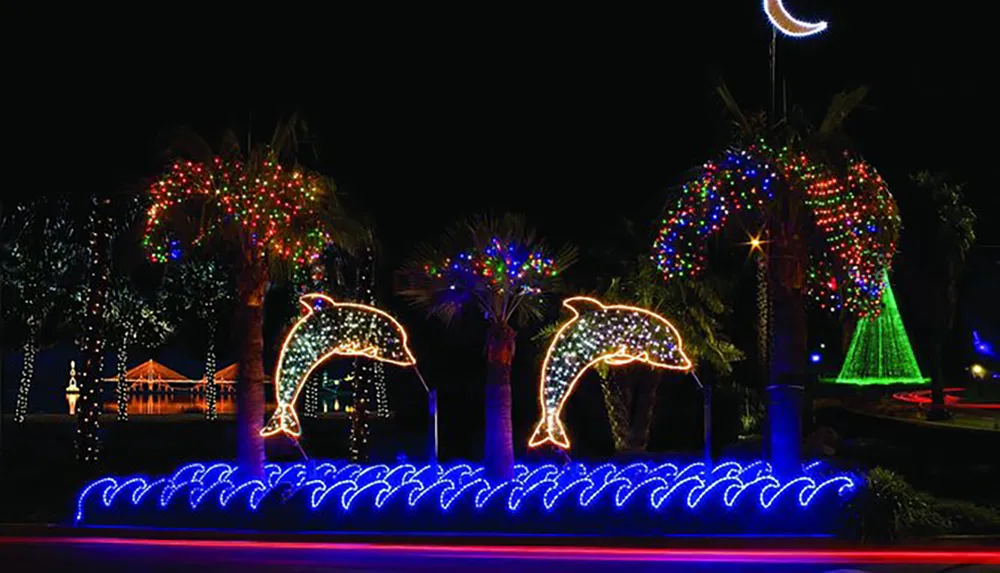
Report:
75,461,863,533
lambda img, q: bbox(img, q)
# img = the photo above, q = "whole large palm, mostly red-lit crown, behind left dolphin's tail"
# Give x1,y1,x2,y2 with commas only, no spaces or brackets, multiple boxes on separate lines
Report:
145,115,358,477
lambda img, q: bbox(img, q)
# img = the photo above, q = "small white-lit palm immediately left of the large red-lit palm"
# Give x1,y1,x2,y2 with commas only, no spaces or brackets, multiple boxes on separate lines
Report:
167,260,234,420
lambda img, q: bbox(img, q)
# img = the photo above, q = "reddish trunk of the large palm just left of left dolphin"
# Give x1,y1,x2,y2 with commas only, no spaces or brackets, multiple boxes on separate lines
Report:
236,263,267,478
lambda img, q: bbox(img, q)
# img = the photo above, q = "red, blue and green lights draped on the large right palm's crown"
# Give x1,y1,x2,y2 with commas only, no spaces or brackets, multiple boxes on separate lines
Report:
654,142,899,317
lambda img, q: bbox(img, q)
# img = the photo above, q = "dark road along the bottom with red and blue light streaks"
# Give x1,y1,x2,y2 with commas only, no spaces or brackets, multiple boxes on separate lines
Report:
0,537,1000,573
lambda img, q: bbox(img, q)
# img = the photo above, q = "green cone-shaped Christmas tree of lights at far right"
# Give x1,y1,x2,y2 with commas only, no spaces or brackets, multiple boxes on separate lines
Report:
824,277,930,386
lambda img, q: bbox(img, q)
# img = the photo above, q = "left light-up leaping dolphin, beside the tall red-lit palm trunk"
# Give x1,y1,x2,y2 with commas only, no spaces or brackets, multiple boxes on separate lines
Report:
260,294,417,437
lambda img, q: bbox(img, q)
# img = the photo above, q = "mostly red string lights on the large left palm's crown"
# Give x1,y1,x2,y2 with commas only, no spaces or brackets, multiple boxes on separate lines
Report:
144,154,332,272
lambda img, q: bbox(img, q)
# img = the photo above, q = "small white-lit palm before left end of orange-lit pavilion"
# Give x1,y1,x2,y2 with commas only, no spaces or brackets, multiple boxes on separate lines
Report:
104,274,173,422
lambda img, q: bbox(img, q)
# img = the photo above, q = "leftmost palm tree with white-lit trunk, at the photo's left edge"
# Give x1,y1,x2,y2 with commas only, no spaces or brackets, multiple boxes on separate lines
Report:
0,202,83,424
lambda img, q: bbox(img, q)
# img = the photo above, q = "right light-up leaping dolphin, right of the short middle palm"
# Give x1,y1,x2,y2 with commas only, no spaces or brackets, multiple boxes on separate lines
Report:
528,296,691,448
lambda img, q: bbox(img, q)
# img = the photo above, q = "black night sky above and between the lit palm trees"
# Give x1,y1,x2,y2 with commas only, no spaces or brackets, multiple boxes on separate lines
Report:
8,0,1000,455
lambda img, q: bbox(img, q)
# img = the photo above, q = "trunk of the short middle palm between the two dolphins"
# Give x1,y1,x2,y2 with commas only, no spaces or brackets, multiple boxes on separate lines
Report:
483,324,517,479
